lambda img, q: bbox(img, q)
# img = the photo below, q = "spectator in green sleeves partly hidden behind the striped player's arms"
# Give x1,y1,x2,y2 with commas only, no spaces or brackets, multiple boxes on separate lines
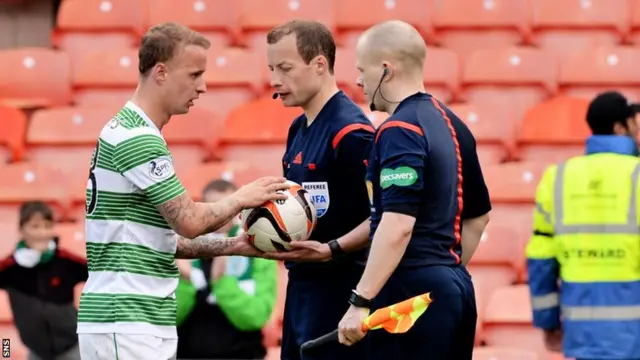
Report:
176,180,277,359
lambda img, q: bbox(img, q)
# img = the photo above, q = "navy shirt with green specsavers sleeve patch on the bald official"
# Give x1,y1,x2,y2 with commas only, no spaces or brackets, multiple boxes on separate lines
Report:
367,93,491,268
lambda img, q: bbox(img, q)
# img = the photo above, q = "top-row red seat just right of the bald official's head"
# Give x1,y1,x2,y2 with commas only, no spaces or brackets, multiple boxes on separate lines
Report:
433,0,530,58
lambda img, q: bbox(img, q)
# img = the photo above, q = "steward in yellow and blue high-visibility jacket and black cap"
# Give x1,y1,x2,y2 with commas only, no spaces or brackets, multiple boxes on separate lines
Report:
527,92,640,360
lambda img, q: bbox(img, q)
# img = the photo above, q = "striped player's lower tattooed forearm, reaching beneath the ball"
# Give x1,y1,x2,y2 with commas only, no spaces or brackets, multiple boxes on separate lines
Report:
175,234,237,259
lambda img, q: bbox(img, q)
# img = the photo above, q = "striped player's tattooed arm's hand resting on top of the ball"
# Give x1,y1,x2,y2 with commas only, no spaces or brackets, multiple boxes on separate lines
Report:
232,176,290,209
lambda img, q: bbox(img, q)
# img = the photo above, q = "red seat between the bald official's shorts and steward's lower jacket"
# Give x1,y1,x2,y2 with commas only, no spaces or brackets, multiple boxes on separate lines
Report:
483,285,548,359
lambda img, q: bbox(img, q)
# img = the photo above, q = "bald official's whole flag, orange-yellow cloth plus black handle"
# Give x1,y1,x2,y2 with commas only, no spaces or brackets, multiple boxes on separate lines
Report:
300,293,432,353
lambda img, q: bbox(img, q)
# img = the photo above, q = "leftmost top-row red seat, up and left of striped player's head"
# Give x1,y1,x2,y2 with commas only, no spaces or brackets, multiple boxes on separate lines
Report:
53,0,144,63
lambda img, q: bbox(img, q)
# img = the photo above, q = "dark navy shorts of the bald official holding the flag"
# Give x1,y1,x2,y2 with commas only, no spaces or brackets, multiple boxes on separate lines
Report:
367,266,477,360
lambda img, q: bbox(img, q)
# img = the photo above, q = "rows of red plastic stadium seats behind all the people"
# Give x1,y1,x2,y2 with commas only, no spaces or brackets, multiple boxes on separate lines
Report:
0,0,640,354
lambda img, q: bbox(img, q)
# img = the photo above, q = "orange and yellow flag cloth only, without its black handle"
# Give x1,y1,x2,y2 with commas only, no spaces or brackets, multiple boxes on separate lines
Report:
362,293,432,334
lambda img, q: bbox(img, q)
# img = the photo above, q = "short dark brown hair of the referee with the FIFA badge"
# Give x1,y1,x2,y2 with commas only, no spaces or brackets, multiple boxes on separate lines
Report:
267,20,336,74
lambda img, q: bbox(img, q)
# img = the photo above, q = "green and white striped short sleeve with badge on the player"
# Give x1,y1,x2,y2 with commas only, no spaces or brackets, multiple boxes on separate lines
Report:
113,134,185,205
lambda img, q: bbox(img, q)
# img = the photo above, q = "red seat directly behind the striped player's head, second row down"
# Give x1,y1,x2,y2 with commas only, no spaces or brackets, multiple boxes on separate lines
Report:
73,48,138,106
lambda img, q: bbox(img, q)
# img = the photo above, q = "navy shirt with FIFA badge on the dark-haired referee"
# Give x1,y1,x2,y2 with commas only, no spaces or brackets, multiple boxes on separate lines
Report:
282,91,375,277
